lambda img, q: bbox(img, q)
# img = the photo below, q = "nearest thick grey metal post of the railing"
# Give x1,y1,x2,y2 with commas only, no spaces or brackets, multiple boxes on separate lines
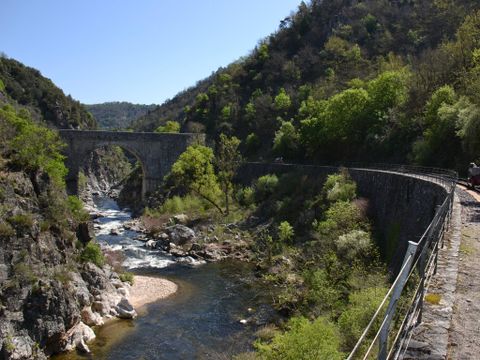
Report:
378,241,418,360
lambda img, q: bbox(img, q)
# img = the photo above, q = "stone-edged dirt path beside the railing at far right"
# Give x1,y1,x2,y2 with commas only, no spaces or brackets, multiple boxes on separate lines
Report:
448,191,480,360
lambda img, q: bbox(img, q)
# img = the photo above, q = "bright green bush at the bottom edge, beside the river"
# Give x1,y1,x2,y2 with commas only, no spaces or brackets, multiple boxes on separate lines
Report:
256,317,345,360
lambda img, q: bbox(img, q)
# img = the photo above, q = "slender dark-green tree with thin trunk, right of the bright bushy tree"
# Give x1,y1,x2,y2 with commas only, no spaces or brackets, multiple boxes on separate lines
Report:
215,134,242,215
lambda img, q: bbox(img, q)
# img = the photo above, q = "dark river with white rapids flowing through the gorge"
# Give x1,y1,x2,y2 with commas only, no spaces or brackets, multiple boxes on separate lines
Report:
55,198,275,360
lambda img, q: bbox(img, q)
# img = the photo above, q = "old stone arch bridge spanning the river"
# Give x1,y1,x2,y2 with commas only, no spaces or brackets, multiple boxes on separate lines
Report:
59,130,205,195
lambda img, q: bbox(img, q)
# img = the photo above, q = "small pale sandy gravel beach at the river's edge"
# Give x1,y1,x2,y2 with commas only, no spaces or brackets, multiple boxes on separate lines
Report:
128,275,178,309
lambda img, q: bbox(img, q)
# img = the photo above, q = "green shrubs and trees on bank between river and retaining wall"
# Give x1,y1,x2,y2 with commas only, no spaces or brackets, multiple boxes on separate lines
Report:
146,135,388,359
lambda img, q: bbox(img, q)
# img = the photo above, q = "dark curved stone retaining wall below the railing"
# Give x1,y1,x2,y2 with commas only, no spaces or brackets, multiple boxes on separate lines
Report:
237,163,447,269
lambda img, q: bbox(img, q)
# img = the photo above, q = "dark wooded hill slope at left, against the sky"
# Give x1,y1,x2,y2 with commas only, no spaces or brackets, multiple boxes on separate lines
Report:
0,56,97,129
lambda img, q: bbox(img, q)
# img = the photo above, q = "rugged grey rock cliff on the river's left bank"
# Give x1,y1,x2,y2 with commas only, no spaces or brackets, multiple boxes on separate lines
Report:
0,170,136,359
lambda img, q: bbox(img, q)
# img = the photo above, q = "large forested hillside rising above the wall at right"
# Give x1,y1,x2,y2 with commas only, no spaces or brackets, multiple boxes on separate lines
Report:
134,0,480,172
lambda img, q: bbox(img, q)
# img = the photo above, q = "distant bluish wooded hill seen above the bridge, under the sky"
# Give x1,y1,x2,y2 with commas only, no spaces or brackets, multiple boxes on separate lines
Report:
84,101,157,129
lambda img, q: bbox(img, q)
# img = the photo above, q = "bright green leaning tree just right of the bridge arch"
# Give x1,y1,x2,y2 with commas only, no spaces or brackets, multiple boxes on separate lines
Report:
169,145,223,214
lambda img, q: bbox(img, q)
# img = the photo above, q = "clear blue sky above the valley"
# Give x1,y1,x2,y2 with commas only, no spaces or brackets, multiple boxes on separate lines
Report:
0,0,300,104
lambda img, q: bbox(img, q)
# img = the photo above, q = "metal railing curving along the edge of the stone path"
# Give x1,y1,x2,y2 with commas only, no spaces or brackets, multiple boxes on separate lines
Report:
343,164,457,360
